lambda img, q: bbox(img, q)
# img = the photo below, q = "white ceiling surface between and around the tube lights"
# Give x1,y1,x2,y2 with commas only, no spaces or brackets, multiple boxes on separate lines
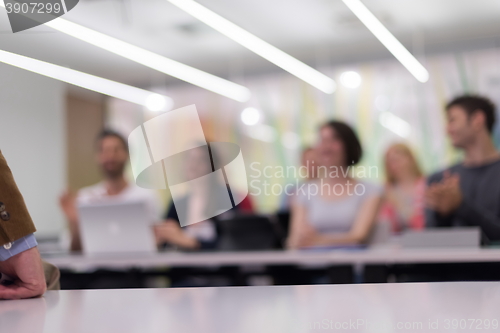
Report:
0,0,500,92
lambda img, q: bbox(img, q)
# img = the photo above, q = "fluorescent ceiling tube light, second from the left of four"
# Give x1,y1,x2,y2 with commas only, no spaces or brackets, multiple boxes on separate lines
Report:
0,0,251,102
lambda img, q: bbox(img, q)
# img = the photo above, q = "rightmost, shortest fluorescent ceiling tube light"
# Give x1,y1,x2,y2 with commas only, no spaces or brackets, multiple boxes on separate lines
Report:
342,0,429,82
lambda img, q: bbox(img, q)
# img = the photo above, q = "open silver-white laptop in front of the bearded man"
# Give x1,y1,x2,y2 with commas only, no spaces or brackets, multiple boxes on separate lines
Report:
78,202,156,254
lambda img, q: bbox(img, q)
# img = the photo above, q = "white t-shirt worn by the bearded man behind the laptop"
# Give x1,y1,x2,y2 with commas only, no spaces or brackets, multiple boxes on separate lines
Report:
76,182,162,223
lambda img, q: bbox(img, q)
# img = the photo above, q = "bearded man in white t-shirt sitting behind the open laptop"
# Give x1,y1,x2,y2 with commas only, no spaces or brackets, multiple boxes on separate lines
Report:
60,130,160,251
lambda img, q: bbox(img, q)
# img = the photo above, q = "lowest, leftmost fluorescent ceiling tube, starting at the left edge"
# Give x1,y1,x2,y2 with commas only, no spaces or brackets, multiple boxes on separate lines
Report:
0,50,173,111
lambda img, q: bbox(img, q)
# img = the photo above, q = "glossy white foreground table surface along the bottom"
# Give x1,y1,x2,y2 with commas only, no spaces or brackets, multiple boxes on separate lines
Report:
0,282,500,333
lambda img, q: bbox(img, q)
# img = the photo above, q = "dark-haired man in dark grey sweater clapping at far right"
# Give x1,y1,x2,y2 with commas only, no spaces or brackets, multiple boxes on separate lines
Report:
425,95,500,241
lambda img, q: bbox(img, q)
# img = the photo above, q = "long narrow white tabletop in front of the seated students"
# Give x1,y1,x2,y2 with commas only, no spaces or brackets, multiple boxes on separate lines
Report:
44,248,500,271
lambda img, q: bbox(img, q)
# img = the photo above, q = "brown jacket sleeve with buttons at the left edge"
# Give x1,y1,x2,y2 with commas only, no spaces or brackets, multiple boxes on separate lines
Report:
0,151,36,246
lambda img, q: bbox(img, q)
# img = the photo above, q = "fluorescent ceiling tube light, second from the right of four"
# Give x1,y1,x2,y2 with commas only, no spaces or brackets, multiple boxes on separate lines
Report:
168,0,336,94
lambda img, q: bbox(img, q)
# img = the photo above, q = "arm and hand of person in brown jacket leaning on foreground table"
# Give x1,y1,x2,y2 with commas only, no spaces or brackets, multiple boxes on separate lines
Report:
0,152,47,299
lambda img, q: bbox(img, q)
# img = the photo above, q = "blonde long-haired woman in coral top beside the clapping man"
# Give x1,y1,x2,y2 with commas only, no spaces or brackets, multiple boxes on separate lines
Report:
379,143,426,233
